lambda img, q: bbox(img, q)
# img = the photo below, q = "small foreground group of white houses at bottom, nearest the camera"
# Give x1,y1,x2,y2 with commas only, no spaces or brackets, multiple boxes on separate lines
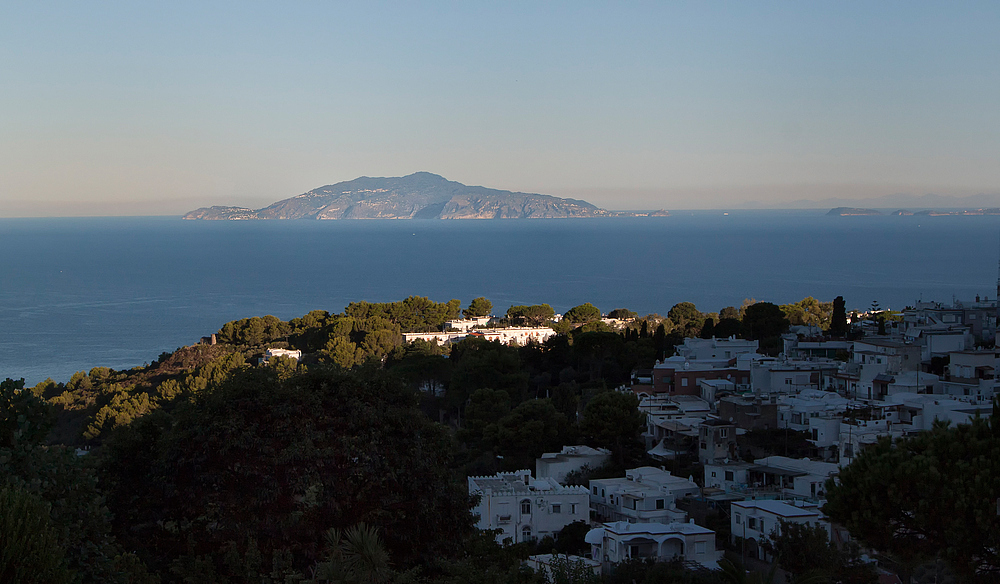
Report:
468,446,721,570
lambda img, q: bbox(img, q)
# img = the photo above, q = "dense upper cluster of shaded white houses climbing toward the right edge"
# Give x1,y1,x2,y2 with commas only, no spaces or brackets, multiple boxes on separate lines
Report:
621,298,1000,472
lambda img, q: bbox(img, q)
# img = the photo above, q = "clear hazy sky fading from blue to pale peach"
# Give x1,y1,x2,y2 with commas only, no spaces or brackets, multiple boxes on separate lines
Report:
0,1,1000,216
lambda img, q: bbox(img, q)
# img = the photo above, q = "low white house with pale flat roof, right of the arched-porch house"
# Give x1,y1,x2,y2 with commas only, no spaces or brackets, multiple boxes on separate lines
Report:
729,500,830,560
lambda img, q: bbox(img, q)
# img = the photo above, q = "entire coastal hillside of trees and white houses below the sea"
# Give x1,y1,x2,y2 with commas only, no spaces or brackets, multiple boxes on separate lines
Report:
9,296,1000,584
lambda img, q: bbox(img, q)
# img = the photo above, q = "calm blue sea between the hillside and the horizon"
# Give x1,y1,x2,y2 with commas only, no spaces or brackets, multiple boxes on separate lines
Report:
0,211,1000,384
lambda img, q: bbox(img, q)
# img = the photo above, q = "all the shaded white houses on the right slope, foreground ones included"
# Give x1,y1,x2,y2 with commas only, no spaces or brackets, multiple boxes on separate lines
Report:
470,297,1000,569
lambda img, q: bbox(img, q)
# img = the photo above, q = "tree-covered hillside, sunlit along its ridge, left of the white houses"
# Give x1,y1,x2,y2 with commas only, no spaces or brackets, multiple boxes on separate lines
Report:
0,297,892,582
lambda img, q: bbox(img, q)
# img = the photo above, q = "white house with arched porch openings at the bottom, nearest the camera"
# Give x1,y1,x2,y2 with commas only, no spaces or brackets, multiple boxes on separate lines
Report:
586,521,722,573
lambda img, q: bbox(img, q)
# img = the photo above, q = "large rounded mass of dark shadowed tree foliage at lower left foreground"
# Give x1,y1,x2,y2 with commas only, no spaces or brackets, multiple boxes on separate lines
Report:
101,367,472,582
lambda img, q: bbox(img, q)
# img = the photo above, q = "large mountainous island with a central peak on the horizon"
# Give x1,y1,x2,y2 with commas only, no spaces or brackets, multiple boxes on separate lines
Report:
184,172,669,221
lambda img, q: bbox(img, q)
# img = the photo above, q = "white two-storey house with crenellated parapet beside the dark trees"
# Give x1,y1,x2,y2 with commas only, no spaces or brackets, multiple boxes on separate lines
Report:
468,470,590,543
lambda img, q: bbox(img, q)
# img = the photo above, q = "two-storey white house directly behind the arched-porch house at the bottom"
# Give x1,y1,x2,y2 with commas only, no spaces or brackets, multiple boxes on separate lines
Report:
590,466,701,523
